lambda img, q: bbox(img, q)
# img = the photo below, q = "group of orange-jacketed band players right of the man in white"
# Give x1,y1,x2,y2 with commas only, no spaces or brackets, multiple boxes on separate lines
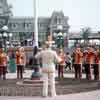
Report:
58,46,100,80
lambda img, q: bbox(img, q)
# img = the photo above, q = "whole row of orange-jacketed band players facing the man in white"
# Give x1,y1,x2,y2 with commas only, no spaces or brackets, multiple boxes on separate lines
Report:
0,44,100,80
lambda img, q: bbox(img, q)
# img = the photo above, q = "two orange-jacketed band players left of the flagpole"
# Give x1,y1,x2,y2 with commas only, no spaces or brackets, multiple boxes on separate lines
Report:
0,47,26,80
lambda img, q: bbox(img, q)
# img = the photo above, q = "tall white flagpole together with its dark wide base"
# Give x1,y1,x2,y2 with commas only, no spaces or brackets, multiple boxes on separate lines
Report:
31,0,41,80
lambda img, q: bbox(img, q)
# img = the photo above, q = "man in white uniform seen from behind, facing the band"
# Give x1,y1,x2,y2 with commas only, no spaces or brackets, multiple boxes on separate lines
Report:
36,43,61,96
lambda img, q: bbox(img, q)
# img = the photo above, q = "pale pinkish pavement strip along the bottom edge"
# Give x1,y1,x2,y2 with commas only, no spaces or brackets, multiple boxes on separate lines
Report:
0,90,100,100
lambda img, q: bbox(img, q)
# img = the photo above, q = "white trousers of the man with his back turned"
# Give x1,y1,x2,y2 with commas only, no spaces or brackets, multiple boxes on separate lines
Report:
43,72,56,96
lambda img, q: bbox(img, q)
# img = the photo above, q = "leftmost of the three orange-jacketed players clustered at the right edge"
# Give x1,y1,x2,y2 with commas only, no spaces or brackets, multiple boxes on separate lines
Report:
73,47,83,79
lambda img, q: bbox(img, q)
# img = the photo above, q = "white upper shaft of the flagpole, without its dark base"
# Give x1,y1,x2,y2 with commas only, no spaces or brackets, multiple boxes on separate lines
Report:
33,0,38,47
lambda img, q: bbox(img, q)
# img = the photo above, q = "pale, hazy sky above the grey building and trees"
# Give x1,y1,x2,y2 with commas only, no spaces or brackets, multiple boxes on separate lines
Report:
8,0,100,31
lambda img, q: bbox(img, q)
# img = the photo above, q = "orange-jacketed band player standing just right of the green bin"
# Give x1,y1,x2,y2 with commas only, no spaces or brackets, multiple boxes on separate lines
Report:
16,47,26,79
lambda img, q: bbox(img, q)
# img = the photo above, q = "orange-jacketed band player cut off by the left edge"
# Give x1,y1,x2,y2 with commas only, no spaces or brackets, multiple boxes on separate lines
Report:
0,48,7,79
